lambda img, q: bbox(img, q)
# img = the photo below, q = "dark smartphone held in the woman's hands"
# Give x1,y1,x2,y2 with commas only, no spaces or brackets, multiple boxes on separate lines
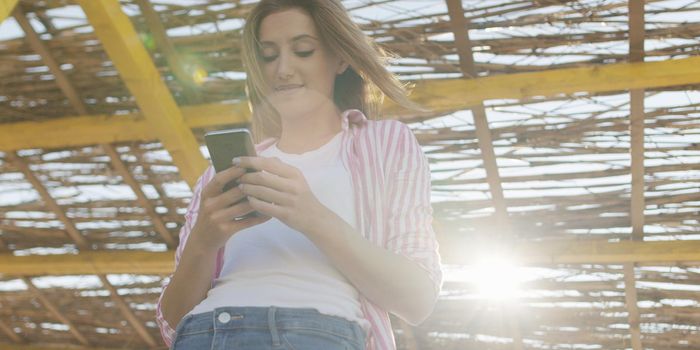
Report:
204,128,259,218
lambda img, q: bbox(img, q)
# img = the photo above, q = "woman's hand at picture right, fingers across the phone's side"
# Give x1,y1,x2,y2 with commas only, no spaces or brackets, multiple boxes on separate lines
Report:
234,157,326,234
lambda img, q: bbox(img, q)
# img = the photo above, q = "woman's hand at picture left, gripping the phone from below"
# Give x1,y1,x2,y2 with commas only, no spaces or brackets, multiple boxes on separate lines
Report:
188,166,271,252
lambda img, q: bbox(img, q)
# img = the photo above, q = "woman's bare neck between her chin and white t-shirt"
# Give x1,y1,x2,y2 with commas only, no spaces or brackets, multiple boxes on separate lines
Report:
277,104,341,154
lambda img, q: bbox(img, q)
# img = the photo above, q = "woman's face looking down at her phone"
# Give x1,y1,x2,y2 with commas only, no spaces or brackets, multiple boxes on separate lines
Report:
259,8,347,118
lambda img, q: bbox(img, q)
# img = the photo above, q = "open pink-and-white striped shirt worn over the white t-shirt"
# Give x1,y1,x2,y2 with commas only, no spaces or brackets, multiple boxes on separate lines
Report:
156,110,442,350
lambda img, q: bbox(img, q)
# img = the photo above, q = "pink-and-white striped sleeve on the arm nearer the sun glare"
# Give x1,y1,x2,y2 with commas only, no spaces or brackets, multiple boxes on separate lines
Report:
384,121,442,297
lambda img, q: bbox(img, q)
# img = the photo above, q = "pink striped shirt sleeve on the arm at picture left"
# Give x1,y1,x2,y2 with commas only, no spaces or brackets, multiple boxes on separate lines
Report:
156,166,214,347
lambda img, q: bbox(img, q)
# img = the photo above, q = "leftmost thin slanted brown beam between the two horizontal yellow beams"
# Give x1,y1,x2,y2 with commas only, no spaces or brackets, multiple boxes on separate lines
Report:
5,152,90,250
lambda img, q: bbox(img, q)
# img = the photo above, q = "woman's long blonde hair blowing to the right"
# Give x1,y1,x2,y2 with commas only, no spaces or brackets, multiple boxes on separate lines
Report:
243,0,422,142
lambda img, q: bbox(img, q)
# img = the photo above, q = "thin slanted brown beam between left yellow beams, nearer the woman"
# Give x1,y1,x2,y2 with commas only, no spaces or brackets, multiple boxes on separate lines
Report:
102,144,177,249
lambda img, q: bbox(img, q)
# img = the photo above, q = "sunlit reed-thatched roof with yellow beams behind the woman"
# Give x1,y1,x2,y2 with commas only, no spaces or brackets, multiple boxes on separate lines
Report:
0,0,700,350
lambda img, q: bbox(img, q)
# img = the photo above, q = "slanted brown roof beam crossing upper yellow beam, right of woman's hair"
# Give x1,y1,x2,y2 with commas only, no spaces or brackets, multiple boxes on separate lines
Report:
446,0,513,241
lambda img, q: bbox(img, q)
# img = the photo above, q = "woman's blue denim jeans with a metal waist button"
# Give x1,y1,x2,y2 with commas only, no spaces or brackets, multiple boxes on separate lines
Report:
170,306,365,350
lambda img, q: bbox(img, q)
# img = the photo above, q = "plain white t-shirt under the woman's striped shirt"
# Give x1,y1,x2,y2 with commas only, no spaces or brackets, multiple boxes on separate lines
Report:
189,133,369,331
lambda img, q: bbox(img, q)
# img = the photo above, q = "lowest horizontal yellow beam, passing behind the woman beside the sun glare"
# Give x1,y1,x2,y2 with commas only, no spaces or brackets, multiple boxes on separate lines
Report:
0,237,700,276
